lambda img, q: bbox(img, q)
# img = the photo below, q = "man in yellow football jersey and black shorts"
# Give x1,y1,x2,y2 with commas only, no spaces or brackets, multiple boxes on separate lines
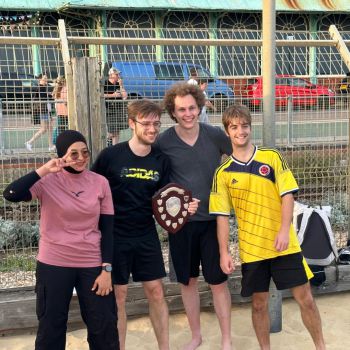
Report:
209,105,325,350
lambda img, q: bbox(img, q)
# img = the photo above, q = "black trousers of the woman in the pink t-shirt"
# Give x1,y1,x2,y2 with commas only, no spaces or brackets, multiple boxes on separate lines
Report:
35,261,119,350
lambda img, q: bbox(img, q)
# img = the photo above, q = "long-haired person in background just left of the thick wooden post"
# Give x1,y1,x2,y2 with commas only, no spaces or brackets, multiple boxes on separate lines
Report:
52,76,68,145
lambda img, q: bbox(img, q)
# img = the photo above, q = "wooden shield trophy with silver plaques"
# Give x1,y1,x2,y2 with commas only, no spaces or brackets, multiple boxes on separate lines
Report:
152,183,192,233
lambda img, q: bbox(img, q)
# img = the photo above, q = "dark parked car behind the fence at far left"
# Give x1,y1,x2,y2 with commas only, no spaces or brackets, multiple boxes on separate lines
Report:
0,72,39,106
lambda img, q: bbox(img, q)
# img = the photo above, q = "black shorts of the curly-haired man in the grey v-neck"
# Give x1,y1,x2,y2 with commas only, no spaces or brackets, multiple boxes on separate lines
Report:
169,220,227,285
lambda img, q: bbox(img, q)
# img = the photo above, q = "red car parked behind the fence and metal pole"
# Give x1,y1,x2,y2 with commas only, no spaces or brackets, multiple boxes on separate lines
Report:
242,75,335,108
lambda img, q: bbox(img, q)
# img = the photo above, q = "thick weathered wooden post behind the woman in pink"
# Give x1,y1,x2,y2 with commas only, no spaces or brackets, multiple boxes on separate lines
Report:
72,57,105,161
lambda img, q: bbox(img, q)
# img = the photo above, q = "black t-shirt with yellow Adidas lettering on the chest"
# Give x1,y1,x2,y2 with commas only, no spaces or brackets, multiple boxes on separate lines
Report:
92,142,170,238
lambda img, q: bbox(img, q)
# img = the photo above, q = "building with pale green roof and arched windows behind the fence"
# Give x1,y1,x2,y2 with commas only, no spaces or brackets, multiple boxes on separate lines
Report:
0,0,350,77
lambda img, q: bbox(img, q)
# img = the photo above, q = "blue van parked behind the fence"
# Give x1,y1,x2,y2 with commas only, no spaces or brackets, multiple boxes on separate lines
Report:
112,62,234,111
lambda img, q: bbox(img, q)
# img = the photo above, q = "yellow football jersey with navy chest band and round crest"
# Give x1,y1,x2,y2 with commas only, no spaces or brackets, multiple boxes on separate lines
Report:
209,147,301,263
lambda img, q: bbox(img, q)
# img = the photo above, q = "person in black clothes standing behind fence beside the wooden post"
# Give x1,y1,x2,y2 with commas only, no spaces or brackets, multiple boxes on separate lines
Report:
104,67,129,145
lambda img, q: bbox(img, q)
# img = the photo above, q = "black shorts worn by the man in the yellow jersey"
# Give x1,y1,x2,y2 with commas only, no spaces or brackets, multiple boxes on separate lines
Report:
241,253,309,297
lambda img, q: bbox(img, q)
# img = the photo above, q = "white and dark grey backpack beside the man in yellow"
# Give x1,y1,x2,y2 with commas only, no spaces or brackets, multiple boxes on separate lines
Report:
293,202,338,286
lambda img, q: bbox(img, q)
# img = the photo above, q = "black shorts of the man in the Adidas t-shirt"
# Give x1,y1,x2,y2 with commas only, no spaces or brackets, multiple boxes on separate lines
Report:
112,233,166,285
